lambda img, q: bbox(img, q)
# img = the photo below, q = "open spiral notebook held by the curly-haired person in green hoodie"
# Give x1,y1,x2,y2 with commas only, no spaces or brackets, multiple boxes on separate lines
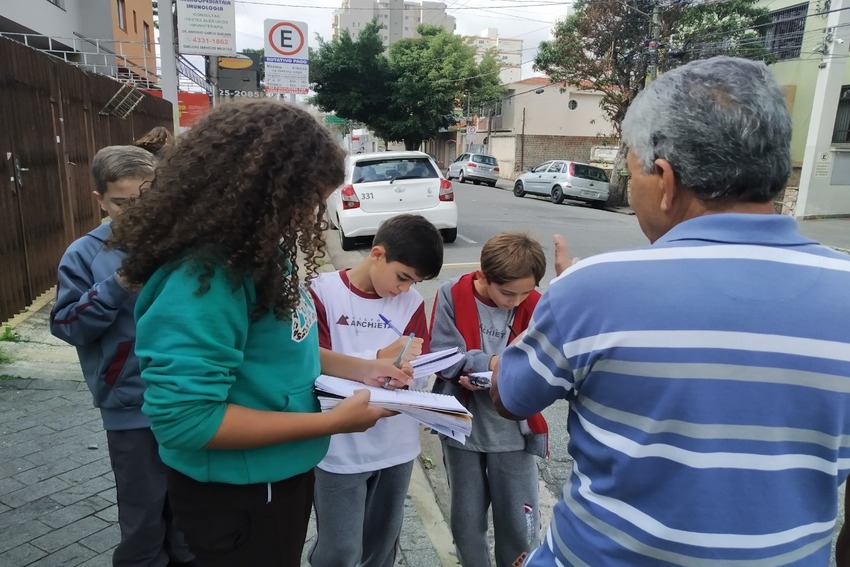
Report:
315,374,472,443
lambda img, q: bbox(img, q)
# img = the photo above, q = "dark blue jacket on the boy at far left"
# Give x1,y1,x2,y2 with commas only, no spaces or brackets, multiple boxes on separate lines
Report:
50,222,150,430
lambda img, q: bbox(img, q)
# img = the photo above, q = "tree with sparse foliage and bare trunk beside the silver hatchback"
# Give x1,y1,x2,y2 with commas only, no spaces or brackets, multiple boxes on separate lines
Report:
534,0,772,205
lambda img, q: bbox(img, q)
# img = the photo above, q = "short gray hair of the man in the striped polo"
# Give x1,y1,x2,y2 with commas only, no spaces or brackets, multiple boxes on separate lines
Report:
622,57,791,203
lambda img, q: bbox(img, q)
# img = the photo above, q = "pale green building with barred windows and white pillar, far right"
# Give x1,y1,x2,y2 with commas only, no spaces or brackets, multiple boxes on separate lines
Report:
760,0,850,218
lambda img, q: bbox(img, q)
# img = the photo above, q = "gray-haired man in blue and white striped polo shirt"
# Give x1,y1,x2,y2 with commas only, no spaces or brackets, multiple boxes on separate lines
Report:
491,57,850,567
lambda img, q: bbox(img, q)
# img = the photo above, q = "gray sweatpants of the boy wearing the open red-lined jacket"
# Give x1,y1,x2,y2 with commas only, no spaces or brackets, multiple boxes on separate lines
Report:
443,443,540,567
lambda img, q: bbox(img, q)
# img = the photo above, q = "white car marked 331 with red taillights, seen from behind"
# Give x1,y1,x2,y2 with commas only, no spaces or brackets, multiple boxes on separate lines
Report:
327,152,457,250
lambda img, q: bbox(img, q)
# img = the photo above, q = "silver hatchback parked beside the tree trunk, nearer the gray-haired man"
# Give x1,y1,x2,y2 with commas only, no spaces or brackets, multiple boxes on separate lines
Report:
514,160,608,208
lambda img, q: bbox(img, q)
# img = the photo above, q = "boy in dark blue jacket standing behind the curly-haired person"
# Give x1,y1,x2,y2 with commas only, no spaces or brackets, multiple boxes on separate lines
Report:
50,146,194,567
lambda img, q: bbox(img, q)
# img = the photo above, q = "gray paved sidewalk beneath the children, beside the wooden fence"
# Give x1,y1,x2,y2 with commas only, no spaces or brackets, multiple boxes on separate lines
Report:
0,296,457,567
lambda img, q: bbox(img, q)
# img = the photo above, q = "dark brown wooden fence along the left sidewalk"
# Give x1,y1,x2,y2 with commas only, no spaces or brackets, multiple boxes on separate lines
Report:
0,38,173,322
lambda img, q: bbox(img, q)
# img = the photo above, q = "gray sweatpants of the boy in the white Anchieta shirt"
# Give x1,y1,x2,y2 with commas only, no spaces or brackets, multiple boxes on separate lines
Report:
309,461,413,567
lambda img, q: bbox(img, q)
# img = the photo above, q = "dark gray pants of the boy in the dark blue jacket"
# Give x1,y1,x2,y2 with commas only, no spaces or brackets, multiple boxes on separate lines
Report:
106,429,193,567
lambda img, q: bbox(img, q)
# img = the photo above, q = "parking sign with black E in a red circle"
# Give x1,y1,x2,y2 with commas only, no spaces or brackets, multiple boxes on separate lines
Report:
263,20,310,94
